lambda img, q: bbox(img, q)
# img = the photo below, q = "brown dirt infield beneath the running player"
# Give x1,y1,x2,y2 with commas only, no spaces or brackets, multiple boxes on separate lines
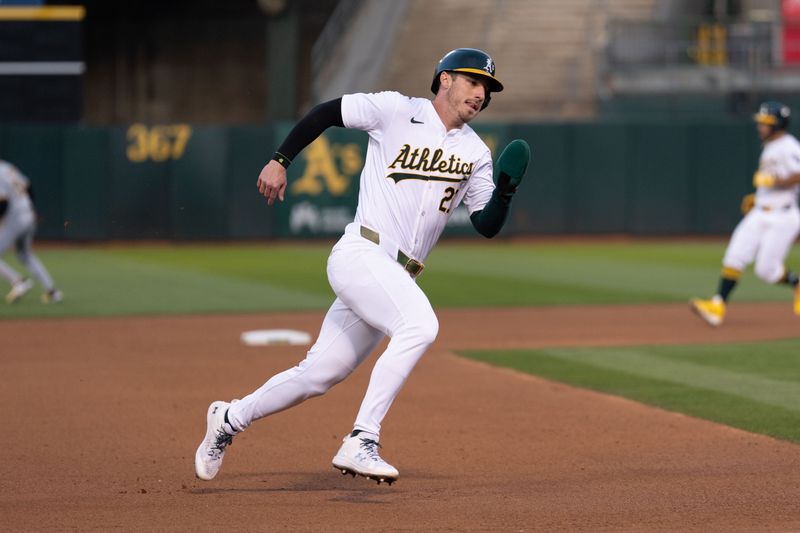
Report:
0,304,800,532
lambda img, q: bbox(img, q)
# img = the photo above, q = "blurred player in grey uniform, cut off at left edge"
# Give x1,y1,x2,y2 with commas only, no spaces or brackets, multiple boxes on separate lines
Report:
0,160,63,303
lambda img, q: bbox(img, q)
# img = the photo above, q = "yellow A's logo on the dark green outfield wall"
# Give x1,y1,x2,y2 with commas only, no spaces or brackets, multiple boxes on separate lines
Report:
291,135,364,196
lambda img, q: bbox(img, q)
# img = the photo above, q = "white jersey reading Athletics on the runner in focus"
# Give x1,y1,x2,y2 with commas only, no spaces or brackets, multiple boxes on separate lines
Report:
342,92,494,261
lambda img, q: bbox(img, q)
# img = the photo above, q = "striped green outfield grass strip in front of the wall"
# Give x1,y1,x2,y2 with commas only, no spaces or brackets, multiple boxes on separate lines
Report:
0,240,800,318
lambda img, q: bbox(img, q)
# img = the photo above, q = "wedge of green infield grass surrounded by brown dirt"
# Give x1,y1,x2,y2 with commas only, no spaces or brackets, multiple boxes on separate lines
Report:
462,339,800,442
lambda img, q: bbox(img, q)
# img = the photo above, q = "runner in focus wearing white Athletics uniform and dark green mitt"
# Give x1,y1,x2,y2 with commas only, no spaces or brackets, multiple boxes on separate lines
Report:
195,48,530,484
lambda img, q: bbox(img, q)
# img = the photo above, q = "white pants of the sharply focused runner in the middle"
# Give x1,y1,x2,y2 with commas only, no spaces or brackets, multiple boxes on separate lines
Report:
228,229,439,435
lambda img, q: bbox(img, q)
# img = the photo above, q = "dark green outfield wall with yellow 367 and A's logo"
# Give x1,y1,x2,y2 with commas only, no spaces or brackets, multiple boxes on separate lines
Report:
0,121,760,241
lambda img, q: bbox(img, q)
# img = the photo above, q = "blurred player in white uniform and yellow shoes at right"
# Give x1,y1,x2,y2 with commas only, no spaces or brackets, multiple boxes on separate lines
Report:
691,102,800,326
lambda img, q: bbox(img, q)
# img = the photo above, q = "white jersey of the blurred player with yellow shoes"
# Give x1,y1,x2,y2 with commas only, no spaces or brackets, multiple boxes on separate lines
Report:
756,133,800,209
